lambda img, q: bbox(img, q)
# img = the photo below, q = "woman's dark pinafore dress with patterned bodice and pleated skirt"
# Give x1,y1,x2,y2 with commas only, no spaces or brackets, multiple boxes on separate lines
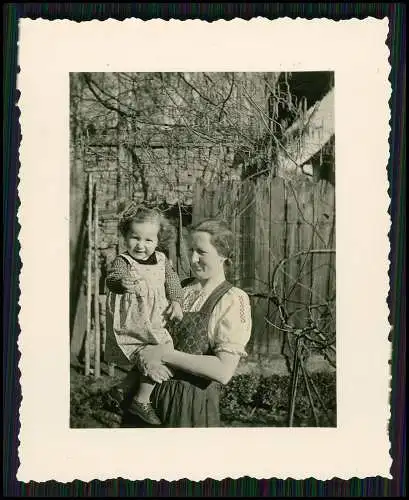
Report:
148,281,232,427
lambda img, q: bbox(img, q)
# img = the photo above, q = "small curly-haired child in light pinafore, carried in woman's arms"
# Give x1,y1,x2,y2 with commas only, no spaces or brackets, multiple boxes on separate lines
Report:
105,204,183,425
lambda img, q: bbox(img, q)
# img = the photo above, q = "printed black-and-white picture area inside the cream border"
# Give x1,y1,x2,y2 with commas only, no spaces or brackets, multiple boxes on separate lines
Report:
69,71,337,429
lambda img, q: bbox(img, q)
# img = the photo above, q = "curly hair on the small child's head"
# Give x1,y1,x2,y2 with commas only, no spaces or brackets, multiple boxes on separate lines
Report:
119,202,176,251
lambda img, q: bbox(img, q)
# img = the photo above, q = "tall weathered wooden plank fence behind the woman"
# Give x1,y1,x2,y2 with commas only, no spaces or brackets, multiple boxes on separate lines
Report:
193,177,335,358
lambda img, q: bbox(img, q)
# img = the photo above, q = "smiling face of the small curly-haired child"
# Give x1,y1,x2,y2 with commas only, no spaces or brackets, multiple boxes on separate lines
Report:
125,222,159,260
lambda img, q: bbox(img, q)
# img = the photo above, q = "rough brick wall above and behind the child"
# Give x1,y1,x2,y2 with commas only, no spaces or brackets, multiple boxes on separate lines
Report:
77,137,240,293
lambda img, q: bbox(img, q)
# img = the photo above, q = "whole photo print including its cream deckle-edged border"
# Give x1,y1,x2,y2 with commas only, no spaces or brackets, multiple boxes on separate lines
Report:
18,18,392,482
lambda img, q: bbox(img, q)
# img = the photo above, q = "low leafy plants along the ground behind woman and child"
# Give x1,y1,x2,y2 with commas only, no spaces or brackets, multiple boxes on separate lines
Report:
70,373,336,428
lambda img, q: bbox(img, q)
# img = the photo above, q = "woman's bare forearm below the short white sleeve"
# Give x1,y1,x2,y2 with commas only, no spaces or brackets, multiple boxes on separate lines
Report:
161,350,240,385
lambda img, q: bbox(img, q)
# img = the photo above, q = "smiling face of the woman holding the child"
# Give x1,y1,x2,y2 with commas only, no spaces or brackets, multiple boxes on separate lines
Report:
190,231,226,280
